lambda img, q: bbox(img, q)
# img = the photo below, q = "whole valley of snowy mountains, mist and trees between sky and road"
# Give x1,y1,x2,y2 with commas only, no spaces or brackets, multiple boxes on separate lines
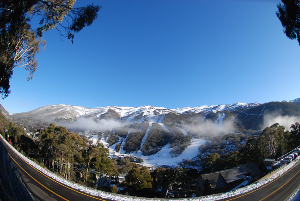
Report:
0,99,300,197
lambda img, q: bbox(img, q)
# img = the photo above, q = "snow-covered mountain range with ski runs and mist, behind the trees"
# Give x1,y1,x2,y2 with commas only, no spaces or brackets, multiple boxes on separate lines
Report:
2,99,300,164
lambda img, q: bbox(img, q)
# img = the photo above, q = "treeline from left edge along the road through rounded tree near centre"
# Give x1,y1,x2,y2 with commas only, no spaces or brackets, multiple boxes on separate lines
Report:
0,113,153,195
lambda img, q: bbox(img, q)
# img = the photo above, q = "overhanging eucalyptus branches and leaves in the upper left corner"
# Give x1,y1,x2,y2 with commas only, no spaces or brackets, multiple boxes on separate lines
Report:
0,0,101,98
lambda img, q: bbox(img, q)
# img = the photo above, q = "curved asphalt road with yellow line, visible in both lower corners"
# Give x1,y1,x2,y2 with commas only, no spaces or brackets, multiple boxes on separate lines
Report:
0,138,300,201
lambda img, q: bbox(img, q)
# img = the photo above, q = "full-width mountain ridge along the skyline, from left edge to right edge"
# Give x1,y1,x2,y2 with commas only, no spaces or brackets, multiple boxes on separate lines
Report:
0,98,300,129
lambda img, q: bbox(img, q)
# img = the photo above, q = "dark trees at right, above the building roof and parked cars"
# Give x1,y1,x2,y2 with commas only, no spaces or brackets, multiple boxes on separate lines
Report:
199,122,300,172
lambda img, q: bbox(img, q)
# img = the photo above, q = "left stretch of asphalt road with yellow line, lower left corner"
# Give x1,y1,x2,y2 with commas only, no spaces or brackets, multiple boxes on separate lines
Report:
0,138,112,201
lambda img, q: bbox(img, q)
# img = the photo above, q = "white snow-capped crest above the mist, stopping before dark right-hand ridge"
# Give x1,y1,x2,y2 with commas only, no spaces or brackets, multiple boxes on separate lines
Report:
6,103,259,122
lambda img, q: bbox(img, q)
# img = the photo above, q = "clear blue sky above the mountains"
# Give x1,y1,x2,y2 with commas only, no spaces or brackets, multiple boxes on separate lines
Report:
0,0,300,113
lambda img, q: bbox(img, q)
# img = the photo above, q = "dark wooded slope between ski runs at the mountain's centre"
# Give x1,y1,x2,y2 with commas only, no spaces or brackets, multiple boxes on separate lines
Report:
104,121,192,157
